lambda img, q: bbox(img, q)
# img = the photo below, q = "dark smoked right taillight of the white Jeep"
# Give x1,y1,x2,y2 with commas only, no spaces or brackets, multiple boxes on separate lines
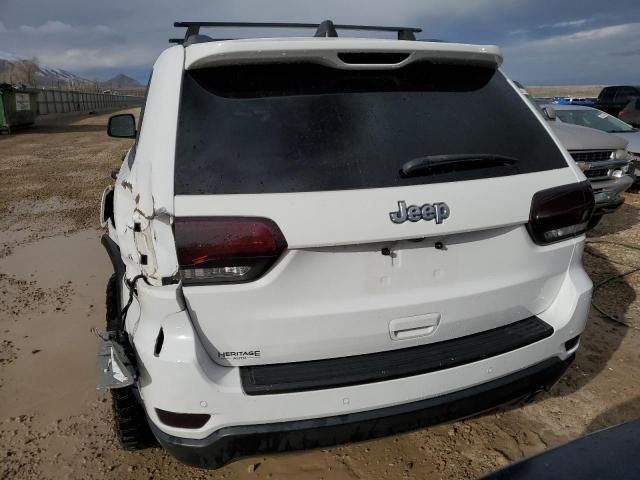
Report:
527,181,595,245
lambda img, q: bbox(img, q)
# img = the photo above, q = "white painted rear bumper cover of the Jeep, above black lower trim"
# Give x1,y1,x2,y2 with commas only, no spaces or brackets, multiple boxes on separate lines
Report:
129,239,592,458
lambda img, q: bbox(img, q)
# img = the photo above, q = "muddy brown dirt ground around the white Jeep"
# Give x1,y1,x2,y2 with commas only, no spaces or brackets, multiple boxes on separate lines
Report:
0,109,640,479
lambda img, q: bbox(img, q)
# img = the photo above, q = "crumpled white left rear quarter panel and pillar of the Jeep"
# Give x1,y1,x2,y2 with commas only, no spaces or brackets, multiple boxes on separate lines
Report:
116,46,184,285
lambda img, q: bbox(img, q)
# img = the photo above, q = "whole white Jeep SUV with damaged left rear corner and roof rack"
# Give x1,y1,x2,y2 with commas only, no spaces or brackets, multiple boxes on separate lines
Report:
99,21,594,468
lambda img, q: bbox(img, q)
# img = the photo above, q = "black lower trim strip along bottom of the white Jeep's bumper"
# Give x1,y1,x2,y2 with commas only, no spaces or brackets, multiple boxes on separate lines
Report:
150,355,574,468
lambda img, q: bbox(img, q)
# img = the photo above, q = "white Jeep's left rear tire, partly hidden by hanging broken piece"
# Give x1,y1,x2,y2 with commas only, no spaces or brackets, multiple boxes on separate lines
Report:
107,275,157,450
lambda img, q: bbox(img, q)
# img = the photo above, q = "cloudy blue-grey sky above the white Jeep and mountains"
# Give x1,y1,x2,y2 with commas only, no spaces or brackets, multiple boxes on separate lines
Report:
0,0,640,85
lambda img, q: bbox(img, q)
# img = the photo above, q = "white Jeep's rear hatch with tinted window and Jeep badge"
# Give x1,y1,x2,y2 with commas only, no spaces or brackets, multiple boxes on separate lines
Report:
175,47,576,365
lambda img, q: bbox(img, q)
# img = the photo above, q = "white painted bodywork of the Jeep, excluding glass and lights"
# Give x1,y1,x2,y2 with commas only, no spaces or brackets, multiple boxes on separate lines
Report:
103,24,592,466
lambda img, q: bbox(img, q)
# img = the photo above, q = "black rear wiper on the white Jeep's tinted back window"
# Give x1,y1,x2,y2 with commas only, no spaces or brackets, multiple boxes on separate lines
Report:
400,153,518,177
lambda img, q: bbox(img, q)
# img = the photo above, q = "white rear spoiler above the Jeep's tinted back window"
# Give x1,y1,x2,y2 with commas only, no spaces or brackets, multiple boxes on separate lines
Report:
184,37,502,70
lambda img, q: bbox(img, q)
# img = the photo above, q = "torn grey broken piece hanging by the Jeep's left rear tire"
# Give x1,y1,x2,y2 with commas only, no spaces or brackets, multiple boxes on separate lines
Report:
97,331,136,391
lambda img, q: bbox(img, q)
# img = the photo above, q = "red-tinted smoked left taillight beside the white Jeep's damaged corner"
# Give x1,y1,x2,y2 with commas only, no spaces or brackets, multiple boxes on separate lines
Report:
174,217,287,284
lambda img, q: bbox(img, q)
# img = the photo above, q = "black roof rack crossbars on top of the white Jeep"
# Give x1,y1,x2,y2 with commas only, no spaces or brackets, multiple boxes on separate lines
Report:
169,20,422,44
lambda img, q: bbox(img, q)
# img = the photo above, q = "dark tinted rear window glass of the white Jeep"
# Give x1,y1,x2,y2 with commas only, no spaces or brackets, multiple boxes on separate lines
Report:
175,62,567,194
